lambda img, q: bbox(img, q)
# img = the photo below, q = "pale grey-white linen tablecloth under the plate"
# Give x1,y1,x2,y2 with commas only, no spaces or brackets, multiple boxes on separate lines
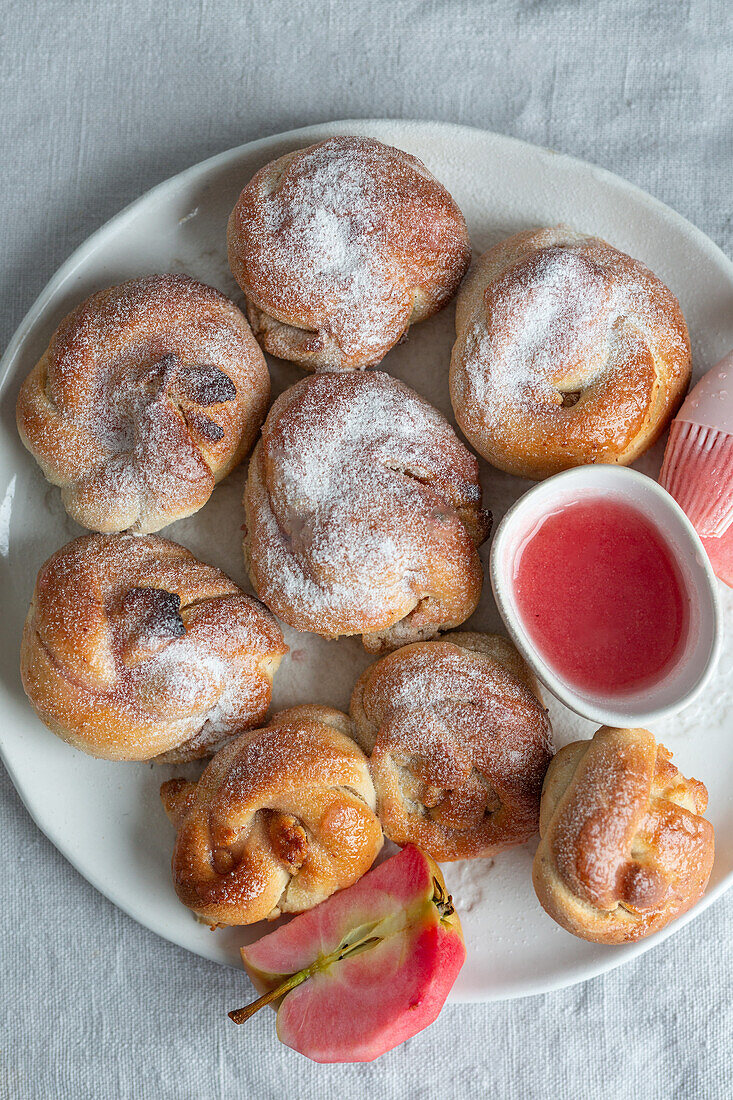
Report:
0,0,733,1100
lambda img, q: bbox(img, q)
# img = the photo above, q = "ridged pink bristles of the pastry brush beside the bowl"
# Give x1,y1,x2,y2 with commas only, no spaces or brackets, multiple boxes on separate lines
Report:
659,420,733,538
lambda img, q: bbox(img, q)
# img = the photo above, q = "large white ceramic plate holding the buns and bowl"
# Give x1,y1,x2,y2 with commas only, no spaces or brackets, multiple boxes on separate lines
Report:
0,121,733,1001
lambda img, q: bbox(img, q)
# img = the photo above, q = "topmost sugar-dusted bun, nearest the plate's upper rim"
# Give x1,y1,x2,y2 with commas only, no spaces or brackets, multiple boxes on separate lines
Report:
228,138,471,371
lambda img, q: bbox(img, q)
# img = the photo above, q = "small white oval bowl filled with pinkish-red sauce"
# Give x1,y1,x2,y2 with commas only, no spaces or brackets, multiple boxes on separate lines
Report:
490,464,722,727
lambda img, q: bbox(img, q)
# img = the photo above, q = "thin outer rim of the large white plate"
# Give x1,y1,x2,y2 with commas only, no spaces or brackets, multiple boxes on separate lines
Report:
0,118,733,1003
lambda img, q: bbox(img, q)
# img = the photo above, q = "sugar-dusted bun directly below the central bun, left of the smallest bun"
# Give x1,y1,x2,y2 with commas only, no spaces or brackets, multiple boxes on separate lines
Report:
351,634,551,860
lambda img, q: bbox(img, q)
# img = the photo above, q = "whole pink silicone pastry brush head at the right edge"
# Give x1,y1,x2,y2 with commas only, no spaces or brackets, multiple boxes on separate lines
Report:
659,352,733,584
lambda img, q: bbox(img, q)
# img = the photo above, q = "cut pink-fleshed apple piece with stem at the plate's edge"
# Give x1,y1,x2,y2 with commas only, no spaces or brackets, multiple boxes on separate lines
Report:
229,845,466,1062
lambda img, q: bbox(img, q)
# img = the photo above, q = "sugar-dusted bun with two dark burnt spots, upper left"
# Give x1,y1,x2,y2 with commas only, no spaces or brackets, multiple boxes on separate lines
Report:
17,275,270,534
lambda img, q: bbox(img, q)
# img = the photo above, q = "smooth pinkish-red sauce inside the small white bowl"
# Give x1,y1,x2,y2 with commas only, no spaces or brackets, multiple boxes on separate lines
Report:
514,497,689,695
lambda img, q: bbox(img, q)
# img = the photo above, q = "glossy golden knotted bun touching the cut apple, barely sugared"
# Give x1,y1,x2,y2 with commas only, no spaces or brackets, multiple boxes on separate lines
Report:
161,706,382,924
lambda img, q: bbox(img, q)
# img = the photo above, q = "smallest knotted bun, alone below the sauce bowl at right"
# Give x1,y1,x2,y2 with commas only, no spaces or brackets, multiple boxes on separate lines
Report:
533,726,714,944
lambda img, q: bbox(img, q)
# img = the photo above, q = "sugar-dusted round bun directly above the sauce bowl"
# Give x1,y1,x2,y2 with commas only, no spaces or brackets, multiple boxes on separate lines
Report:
450,226,690,479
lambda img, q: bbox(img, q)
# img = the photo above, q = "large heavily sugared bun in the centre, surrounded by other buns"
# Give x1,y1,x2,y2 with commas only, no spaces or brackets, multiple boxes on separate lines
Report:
244,372,489,652
